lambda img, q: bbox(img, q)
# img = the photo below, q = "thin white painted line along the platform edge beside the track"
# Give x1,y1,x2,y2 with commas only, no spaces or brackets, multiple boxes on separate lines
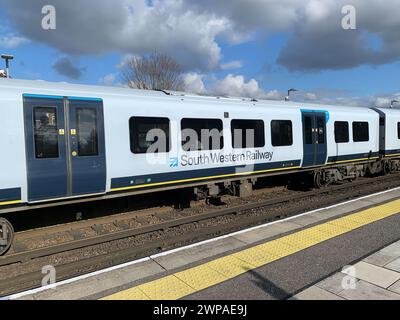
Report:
5,187,400,300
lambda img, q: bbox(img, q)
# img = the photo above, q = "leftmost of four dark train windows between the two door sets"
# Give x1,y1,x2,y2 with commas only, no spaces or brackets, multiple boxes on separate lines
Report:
129,117,171,154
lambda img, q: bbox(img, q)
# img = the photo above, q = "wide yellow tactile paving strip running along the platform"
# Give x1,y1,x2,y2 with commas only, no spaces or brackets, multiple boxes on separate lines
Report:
102,200,400,300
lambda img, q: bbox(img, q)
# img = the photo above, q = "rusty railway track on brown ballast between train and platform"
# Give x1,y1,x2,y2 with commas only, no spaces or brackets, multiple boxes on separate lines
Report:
0,174,400,295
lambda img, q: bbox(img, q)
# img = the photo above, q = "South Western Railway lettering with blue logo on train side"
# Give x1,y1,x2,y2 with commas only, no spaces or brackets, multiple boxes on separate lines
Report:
176,151,274,168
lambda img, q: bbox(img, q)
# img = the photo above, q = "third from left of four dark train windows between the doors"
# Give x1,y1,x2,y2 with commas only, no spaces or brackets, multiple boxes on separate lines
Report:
231,120,265,149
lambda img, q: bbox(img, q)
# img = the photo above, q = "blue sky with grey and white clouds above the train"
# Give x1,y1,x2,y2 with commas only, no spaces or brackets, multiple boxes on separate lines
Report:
0,0,400,107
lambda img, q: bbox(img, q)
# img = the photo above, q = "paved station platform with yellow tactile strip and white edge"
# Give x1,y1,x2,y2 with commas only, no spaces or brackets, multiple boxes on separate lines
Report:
9,188,400,300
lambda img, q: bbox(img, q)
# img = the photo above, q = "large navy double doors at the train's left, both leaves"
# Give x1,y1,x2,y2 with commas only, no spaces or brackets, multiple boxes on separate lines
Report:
24,95,106,202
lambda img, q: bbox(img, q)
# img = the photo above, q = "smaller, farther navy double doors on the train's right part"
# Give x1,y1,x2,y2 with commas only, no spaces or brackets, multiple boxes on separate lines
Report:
302,111,328,167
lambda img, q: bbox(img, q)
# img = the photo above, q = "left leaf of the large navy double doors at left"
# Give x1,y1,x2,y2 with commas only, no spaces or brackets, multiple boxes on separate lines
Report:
24,96,68,201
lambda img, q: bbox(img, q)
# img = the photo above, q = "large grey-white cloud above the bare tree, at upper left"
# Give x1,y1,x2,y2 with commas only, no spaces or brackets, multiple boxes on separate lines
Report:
0,0,235,70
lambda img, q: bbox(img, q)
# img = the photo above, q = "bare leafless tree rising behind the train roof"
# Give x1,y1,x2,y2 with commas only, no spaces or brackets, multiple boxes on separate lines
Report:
121,52,184,91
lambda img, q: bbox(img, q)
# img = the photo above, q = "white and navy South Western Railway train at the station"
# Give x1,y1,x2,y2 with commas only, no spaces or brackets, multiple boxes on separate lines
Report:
0,79,400,242
